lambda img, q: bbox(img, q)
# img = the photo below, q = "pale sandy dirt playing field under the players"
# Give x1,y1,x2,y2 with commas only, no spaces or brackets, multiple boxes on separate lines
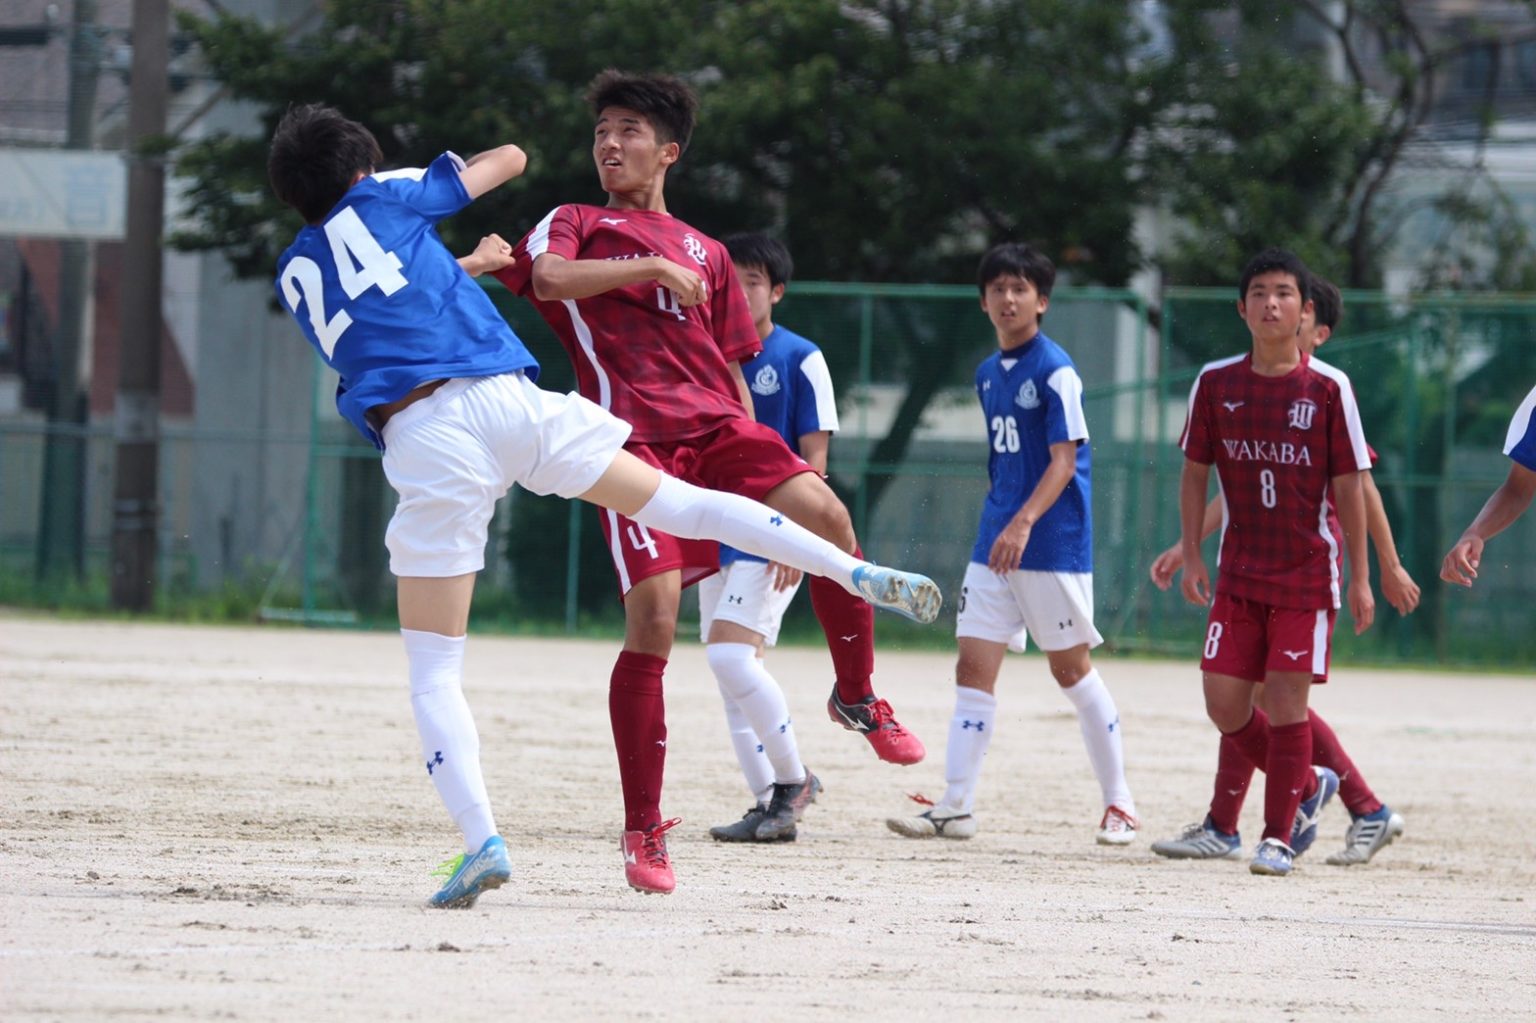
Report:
0,616,1536,1021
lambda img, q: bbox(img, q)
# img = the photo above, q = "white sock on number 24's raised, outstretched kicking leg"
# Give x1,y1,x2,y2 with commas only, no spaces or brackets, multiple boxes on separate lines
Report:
630,473,865,596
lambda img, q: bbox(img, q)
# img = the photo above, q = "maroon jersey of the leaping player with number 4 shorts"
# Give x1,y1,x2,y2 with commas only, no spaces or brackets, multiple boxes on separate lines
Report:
496,204,762,444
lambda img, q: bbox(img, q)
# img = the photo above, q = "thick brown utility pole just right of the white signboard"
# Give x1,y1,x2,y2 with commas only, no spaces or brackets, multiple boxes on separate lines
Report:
112,0,170,611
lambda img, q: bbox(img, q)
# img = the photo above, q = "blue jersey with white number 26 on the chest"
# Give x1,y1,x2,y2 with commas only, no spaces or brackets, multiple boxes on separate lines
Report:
971,333,1094,571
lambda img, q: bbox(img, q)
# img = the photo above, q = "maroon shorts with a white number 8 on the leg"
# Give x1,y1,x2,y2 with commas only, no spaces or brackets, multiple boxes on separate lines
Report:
1200,591,1338,682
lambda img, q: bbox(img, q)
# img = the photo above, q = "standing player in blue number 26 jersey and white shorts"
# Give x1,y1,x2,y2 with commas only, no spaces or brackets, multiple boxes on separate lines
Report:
886,243,1138,845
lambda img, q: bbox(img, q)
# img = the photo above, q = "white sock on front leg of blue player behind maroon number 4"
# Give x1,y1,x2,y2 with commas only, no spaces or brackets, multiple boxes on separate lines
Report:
705,644,805,802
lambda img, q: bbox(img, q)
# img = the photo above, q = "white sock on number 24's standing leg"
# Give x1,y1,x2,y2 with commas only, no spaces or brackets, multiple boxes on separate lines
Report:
399,628,496,853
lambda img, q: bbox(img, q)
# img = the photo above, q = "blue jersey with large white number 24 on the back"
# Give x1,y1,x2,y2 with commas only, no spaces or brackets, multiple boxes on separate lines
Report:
276,152,539,449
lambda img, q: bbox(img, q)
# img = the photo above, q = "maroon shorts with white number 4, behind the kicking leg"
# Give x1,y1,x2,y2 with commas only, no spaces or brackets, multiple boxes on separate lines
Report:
598,418,816,593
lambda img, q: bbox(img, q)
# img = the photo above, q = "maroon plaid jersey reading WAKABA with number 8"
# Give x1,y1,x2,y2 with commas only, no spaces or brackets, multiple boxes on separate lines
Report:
1180,355,1370,610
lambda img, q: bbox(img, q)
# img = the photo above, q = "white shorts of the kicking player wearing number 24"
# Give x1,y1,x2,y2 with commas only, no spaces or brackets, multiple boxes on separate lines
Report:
384,372,630,578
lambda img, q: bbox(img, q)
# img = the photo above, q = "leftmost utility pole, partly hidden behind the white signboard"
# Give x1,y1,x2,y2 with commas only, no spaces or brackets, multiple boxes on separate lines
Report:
37,0,101,579
